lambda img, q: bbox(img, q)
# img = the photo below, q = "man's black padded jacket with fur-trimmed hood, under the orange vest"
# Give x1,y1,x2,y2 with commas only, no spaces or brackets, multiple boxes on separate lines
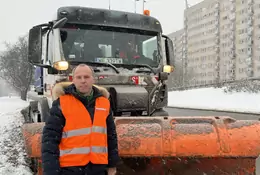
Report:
41,84,119,175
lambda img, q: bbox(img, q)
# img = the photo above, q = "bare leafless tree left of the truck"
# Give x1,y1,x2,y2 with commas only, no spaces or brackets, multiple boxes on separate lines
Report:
0,35,33,100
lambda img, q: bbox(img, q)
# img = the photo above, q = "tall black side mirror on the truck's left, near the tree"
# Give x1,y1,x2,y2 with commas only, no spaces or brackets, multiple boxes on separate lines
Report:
28,26,42,65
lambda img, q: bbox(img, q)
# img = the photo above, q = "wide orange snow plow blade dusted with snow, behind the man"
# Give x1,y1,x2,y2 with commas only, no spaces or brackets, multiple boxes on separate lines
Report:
22,117,260,175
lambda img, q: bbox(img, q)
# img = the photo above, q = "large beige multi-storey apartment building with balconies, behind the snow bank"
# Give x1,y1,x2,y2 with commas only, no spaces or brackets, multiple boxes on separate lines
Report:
170,0,260,85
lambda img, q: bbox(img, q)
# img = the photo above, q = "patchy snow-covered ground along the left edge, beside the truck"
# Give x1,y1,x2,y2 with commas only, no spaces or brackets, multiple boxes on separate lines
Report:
0,97,32,175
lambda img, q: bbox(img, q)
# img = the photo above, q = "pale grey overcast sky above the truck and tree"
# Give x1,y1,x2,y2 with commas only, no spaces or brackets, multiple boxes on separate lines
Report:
0,0,202,51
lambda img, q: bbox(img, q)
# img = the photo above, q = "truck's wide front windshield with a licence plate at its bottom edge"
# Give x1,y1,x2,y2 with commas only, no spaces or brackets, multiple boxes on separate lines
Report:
60,26,160,67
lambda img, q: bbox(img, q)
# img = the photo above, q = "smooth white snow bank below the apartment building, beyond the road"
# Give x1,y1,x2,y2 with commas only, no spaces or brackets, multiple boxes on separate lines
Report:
168,88,260,113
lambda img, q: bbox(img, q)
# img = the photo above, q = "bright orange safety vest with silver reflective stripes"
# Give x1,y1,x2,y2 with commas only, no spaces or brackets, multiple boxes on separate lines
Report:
59,95,110,167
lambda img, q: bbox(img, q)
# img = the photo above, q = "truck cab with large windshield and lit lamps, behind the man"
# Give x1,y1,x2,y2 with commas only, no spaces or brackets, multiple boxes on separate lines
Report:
28,6,174,122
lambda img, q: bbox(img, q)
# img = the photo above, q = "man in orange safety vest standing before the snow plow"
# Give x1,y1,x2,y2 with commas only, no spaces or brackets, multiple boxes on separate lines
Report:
42,64,119,175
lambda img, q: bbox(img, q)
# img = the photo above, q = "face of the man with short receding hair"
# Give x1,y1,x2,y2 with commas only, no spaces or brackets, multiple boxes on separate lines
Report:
73,66,94,94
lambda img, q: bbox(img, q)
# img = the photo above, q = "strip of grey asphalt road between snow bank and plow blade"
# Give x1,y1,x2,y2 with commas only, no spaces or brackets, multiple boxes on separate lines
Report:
165,108,260,120
